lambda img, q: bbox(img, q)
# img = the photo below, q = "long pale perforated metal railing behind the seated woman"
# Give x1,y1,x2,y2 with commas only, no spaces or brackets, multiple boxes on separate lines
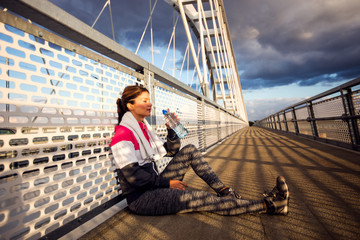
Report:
0,1,248,239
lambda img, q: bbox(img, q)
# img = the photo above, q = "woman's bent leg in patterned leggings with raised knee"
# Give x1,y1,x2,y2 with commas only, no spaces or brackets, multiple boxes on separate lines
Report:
161,144,225,192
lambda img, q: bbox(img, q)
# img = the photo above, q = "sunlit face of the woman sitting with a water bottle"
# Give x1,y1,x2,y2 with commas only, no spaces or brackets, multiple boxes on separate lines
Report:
127,91,152,122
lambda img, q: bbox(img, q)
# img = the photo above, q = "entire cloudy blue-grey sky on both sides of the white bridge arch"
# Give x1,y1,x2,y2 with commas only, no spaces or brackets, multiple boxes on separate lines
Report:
51,0,360,121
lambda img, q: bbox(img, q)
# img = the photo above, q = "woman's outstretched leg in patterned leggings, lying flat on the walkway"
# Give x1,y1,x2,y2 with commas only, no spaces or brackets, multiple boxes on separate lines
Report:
129,188,265,216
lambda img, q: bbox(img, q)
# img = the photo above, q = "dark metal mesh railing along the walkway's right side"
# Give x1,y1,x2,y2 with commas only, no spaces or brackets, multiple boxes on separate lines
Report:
256,78,360,151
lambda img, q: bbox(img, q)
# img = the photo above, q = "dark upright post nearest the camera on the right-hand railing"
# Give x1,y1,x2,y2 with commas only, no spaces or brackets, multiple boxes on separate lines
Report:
341,88,360,145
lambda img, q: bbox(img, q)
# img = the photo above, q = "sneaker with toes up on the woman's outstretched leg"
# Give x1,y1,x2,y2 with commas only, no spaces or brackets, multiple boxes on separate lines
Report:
264,176,290,215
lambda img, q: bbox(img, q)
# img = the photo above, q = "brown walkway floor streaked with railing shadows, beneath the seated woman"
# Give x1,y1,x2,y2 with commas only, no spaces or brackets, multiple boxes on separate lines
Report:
82,127,360,240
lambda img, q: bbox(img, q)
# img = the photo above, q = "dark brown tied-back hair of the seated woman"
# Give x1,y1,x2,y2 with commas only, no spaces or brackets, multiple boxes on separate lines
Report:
116,85,149,124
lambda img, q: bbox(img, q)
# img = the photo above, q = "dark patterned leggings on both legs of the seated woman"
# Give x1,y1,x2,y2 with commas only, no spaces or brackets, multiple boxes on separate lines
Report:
129,144,265,216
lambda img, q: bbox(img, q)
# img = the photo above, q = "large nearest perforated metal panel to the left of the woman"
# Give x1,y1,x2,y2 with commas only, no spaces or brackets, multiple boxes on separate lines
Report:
0,24,137,238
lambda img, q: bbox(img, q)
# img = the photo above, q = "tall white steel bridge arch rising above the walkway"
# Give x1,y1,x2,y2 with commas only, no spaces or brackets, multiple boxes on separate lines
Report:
165,0,248,121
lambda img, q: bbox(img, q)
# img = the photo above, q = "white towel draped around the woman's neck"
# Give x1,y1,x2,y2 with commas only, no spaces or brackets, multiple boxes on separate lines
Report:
120,111,166,161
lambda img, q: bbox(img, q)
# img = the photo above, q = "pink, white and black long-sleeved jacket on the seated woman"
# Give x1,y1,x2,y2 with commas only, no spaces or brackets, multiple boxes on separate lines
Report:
110,122,180,204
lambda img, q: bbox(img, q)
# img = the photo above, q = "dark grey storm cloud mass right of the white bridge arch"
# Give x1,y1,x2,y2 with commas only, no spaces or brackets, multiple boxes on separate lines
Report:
224,0,360,89
